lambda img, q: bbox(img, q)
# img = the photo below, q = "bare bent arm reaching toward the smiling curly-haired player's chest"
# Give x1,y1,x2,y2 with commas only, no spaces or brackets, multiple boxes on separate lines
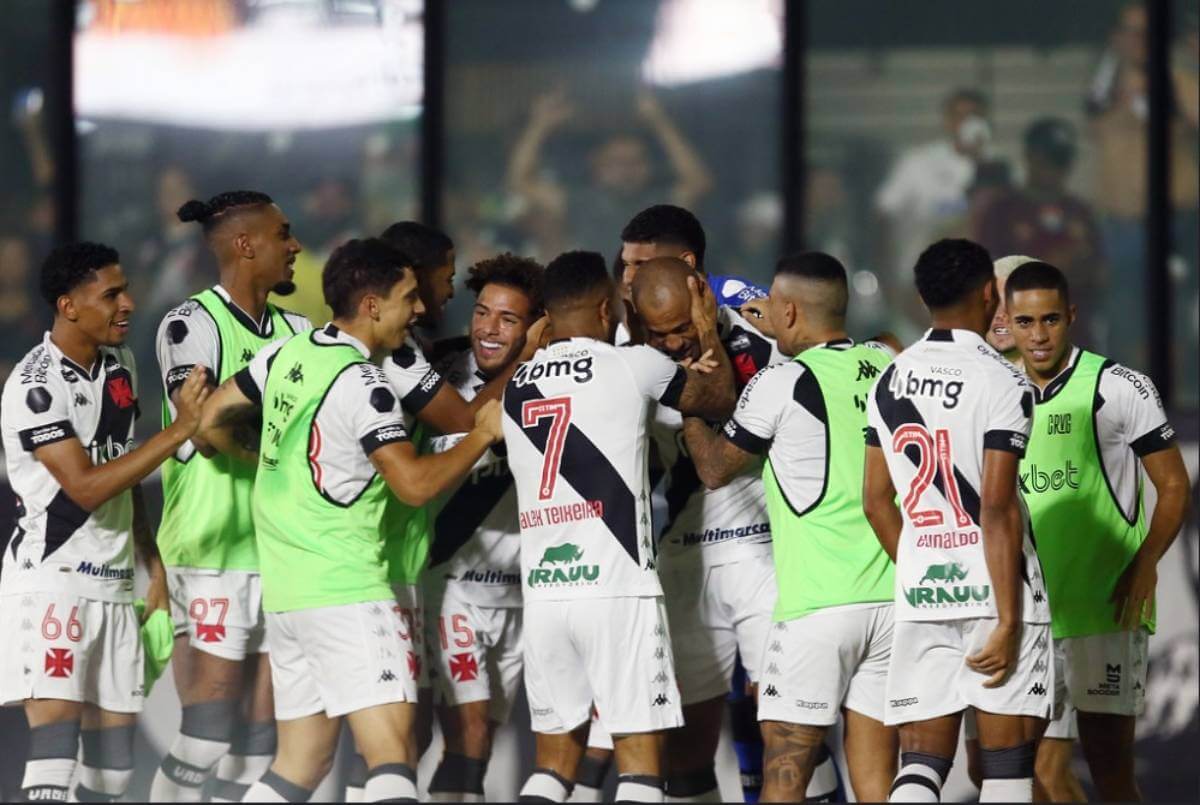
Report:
371,400,504,506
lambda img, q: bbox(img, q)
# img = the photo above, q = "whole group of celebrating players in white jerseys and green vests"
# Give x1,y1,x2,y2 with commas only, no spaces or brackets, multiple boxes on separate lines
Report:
0,192,1188,801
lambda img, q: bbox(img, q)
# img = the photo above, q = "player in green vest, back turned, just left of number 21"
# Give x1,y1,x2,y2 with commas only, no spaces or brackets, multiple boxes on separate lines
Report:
684,252,898,801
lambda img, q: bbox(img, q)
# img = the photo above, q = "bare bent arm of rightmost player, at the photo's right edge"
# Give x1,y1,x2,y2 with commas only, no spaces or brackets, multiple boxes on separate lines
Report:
1112,444,1190,629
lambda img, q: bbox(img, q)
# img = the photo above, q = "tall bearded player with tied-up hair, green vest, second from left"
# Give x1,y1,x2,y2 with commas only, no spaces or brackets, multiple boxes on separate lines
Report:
150,191,312,803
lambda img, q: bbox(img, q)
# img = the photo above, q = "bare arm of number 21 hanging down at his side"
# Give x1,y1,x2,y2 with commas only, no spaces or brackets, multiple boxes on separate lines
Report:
966,449,1024,687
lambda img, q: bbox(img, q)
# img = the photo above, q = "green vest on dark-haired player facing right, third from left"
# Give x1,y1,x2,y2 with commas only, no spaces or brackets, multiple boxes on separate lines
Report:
252,334,391,612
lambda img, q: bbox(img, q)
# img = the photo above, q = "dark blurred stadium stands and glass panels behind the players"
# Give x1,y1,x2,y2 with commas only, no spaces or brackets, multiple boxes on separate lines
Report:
0,0,1200,800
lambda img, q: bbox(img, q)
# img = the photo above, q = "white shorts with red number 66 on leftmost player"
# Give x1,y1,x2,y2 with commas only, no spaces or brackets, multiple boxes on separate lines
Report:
0,591,145,713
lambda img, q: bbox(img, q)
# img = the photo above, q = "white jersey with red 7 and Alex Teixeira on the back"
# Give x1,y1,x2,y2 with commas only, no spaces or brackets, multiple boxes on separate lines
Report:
504,338,686,601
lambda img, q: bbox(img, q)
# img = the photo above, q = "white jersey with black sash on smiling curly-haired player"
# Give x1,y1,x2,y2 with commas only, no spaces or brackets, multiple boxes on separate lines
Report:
430,348,521,607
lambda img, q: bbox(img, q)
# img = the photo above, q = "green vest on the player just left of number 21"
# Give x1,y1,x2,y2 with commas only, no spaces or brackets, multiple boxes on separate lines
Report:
762,346,895,621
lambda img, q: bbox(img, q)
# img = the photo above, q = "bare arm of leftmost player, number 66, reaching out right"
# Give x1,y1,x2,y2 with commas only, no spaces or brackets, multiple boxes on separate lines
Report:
34,367,209,511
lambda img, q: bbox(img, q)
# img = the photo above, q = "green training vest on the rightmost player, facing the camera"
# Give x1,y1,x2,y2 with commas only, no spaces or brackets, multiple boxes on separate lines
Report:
1020,352,1154,637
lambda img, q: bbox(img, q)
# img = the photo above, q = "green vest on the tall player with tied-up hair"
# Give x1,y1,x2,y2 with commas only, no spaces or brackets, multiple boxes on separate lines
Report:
157,288,292,571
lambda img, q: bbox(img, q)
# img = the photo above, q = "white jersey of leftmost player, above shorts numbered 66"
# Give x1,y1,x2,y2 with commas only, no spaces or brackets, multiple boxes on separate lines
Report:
0,332,138,602
